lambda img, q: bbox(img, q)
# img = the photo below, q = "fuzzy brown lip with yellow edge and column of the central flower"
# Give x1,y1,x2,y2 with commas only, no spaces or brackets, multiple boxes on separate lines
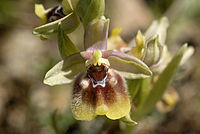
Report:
72,49,130,120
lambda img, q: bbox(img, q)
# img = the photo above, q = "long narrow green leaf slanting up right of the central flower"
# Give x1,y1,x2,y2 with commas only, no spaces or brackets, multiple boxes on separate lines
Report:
132,44,187,120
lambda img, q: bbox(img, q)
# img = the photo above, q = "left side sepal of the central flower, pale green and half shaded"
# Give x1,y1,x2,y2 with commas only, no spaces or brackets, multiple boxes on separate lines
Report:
44,53,85,86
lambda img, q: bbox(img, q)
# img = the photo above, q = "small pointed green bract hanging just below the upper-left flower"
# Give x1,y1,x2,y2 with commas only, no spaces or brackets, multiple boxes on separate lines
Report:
58,24,79,58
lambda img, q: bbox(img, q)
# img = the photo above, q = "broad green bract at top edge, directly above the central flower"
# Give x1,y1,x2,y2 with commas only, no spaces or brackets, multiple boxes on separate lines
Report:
77,0,105,28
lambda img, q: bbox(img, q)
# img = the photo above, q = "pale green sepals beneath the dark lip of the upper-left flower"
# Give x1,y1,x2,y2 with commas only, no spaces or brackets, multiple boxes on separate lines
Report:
33,12,79,39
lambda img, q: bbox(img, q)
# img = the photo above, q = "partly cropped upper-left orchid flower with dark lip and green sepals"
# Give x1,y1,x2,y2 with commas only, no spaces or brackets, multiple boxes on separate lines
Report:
33,0,80,39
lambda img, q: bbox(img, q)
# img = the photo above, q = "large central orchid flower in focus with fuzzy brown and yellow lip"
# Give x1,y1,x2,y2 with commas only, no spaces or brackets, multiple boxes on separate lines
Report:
44,16,152,120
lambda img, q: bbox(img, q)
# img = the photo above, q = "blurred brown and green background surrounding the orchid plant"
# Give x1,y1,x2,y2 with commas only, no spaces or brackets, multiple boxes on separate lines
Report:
0,0,200,134
